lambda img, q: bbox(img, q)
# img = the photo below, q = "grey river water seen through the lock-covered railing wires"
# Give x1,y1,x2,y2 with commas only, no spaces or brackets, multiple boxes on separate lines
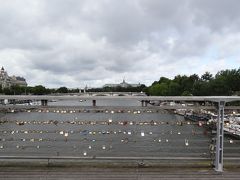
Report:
0,100,239,157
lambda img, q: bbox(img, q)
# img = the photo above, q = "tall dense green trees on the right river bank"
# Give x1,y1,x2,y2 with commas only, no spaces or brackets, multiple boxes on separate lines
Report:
146,68,240,96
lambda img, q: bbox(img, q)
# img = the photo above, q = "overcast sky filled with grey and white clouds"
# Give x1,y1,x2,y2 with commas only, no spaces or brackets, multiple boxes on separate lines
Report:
0,0,240,87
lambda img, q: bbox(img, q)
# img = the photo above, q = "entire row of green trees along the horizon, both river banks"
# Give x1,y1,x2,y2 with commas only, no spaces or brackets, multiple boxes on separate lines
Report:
0,68,240,96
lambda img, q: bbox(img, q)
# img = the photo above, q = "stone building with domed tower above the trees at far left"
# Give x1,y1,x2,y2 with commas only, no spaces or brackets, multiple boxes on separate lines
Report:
0,67,27,89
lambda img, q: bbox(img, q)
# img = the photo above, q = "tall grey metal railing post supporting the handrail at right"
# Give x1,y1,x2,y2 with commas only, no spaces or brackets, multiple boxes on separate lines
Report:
215,101,225,172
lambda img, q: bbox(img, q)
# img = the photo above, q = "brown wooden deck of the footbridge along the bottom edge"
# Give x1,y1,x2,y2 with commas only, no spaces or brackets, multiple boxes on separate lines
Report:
0,167,240,180
